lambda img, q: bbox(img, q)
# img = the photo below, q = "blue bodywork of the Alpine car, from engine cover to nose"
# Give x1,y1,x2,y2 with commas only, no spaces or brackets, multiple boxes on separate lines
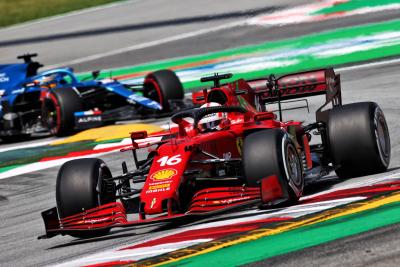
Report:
0,55,162,136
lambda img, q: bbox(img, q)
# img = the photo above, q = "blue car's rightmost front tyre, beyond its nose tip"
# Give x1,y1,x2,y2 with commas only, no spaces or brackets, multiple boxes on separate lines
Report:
144,70,184,112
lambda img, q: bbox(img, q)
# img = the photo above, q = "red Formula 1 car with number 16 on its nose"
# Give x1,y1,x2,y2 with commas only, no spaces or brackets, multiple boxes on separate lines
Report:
38,69,390,238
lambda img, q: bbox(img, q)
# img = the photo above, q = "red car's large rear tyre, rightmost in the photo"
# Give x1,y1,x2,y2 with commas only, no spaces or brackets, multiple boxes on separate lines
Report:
328,102,390,178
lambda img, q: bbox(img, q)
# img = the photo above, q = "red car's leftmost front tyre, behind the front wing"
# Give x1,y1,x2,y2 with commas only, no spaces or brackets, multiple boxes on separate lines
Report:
56,158,115,238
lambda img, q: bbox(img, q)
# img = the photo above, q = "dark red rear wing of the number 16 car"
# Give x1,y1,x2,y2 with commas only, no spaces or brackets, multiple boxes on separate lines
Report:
247,68,342,121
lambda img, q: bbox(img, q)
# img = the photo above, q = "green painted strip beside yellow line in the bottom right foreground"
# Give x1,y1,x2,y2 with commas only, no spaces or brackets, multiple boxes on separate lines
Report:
163,202,400,267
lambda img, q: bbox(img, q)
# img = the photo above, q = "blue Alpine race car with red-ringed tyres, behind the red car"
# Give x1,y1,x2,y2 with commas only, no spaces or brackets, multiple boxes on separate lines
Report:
0,54,184,139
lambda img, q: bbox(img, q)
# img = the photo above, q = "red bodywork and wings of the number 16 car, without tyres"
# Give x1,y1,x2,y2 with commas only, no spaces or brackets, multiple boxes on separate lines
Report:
42,69,341,240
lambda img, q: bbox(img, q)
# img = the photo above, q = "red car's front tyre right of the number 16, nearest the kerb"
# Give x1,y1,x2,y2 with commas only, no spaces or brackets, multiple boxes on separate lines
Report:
243,129,304,203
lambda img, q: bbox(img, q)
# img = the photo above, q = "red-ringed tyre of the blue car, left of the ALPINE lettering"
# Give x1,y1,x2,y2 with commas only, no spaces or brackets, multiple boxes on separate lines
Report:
42,88,82,136
